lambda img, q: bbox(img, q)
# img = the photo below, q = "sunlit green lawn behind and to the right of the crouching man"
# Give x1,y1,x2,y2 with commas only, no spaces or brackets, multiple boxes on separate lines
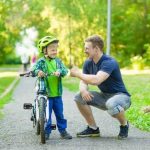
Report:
63,74,150,131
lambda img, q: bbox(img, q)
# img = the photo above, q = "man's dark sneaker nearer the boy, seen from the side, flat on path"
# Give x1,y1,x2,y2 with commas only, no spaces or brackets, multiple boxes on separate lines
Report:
77,126,100,137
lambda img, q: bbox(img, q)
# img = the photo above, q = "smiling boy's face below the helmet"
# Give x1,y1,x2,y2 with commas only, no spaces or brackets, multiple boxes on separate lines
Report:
44,43,58,58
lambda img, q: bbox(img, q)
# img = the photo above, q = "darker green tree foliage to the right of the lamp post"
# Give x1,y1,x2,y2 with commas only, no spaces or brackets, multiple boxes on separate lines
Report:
112,0,150,66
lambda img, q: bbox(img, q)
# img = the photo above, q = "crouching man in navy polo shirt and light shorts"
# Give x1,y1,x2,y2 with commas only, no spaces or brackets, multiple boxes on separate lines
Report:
70,35,131,139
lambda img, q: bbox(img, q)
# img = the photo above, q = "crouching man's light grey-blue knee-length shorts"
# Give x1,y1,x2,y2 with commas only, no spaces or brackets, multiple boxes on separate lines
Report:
74,91,131,115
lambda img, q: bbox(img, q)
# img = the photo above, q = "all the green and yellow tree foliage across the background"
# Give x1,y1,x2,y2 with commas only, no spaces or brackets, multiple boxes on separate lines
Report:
0,0,150,67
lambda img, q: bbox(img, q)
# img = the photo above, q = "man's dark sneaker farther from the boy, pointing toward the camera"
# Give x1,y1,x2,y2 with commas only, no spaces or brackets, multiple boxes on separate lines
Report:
118,122,129,139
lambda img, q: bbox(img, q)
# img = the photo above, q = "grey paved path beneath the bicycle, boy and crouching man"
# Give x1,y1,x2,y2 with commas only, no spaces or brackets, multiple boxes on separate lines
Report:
0,78,150,150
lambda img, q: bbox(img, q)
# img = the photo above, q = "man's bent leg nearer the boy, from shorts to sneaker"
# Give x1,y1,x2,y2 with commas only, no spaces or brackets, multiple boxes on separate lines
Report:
75,91,105,137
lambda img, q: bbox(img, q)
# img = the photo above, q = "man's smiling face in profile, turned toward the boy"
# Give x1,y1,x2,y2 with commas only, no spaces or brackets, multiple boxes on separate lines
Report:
84,42,97,59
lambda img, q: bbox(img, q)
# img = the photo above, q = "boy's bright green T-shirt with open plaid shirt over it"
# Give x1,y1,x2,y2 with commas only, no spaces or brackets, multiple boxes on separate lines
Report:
32,57,68,97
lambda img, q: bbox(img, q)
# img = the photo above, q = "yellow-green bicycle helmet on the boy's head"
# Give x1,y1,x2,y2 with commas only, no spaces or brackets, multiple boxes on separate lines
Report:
37,36,59,53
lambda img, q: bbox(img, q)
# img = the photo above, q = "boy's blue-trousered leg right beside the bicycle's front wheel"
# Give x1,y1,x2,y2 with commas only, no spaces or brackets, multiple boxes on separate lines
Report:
45,98,54,135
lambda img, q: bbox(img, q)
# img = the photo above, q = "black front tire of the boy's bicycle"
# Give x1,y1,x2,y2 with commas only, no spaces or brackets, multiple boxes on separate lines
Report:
39,97,45,144
